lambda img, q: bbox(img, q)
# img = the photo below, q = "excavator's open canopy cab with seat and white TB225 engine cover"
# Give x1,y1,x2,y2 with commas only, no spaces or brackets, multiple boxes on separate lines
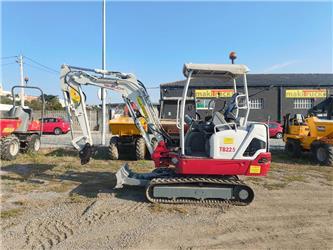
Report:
179,64,268,159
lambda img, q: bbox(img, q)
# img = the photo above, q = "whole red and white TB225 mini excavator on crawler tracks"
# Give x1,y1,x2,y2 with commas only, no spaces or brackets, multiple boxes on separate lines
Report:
60,64,271,205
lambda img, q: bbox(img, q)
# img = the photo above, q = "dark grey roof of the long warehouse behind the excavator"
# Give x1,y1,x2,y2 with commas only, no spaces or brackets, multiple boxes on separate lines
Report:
160,74,333,88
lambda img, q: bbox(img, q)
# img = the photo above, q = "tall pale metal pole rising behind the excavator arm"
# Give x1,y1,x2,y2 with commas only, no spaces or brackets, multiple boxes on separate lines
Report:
101,0,106,145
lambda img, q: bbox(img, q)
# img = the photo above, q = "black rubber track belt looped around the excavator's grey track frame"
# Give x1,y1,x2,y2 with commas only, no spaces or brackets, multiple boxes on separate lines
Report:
146,177,253,206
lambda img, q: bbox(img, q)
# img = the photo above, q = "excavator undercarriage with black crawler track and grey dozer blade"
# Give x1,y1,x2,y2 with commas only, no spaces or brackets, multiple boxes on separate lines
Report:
116,165,254,205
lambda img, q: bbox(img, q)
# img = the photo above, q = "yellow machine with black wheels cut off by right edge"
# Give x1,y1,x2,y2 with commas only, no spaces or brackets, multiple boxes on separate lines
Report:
283,114,333,166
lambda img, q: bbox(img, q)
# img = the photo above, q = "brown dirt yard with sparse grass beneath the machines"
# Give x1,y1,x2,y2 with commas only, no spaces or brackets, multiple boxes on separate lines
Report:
1,149,333,249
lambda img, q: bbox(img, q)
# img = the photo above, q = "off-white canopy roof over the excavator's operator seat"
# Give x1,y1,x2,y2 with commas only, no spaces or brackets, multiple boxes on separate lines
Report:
183,63,249,80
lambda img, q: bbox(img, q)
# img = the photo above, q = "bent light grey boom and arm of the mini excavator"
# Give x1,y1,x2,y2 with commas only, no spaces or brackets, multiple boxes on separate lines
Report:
60,65,168,164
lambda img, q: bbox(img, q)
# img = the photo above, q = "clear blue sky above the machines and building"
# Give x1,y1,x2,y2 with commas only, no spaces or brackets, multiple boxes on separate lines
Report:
1,1,333,104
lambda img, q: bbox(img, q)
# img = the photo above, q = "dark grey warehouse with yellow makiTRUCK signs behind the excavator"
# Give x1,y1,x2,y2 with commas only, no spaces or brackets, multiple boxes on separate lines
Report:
160,74,333,121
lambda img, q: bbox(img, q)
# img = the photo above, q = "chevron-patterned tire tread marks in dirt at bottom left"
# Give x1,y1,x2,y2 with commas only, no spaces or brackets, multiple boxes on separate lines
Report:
24,199,148,249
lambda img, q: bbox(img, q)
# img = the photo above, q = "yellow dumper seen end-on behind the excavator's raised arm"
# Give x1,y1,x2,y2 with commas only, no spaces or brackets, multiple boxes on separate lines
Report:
109,115,148,160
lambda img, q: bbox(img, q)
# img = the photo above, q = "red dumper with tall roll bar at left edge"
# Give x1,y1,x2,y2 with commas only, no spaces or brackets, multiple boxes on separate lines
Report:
0,86,45,161
